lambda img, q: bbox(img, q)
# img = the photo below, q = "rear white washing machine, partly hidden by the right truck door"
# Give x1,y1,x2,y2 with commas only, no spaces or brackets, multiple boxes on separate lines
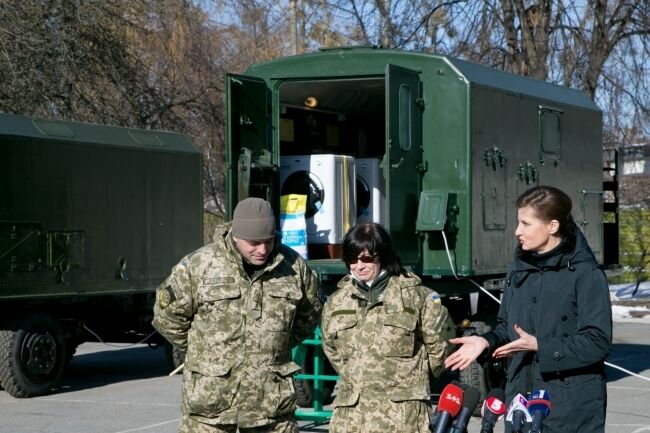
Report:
355,158,386,225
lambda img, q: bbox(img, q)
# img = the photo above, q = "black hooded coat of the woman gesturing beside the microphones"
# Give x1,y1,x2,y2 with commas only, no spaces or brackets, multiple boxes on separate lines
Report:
483,230,612,433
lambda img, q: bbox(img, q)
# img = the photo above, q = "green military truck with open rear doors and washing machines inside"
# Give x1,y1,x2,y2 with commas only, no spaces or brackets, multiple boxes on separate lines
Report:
226,47,618,410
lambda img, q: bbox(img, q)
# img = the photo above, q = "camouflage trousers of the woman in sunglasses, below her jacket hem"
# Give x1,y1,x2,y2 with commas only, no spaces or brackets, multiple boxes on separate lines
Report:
328,397,431,433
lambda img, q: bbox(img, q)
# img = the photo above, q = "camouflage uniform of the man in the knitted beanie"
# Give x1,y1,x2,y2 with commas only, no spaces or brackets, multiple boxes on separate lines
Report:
153,224,322,433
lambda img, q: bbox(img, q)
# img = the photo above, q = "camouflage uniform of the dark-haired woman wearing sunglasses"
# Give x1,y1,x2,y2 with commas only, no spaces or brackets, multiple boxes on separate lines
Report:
321,274,455,433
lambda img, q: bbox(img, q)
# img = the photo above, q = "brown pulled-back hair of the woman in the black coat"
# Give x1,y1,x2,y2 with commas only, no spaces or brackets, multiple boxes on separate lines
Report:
517,185,576,238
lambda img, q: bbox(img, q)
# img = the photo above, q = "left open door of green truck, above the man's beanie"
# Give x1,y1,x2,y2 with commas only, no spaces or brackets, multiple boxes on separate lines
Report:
226,74,278,219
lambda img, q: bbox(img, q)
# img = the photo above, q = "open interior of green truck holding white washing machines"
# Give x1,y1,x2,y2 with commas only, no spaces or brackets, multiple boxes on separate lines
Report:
279,77,385,259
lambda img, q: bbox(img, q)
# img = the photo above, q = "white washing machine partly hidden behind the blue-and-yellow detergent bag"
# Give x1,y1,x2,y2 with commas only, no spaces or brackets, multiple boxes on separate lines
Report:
280,154,357,245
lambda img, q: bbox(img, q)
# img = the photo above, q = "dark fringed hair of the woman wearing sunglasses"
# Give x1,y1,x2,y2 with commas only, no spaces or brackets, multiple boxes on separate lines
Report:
342,223,407,275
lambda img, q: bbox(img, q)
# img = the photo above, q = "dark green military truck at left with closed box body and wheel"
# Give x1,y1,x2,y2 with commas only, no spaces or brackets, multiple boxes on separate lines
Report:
0,114,203,397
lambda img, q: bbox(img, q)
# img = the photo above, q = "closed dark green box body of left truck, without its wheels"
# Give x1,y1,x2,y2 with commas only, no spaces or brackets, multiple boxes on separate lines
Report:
0,115,203,299
